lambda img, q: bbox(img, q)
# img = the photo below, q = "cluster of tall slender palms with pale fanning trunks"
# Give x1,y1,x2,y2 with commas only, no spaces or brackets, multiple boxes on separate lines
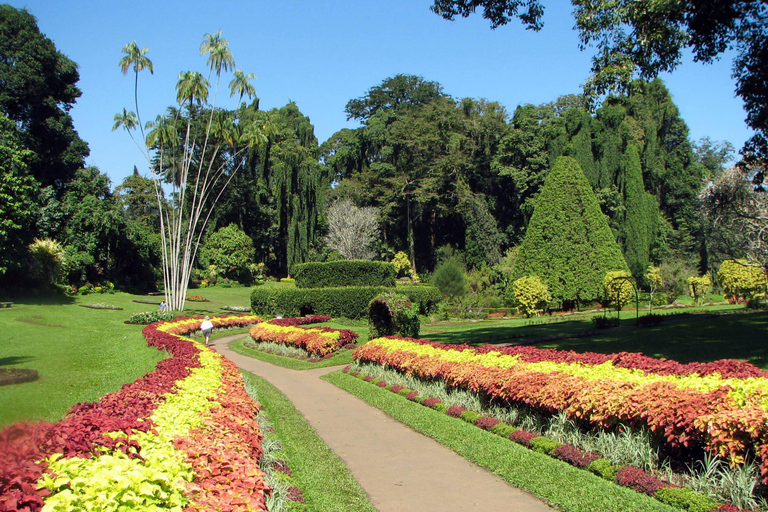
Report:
115,32,258,311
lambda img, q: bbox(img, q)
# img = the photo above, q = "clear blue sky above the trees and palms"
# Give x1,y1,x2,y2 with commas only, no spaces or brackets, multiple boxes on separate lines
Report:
10,0,751,185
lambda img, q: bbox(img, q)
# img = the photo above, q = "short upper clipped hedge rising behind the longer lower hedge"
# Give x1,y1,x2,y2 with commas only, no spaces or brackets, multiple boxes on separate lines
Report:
291,260,397,288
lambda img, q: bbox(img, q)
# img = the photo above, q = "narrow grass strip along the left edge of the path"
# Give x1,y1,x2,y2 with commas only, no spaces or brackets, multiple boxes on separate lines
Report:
241,370,376,512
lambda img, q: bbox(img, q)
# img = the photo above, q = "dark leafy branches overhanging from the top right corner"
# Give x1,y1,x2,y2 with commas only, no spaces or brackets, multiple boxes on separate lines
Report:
431,0,768,166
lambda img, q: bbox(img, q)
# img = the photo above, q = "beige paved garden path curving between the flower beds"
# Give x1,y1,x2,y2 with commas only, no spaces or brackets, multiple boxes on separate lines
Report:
213,334,555,512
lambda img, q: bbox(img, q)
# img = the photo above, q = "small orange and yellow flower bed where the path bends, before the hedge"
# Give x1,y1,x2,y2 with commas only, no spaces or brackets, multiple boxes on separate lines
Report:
249,315,357,357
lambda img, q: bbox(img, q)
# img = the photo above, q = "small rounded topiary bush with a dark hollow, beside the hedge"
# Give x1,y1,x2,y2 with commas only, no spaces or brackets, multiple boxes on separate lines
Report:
368,293,421,339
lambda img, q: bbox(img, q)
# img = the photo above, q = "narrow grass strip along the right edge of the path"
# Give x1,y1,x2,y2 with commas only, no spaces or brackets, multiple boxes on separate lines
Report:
322,371,679,512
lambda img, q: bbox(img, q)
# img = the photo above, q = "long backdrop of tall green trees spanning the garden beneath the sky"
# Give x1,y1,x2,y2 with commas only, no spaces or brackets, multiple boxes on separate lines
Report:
0,3,766,308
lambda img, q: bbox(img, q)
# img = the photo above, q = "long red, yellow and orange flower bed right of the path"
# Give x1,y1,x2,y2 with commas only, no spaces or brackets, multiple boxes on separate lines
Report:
353,337,768,482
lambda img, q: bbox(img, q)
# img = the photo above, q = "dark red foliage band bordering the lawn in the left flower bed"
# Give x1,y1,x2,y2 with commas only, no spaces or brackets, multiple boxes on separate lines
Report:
0,317,268,512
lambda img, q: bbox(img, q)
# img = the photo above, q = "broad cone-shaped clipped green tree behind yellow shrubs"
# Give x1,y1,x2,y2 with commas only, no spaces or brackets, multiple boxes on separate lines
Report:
512,157,629,305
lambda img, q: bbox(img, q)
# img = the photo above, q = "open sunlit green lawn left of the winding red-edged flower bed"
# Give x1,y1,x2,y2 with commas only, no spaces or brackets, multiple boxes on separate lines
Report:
0,288,258,427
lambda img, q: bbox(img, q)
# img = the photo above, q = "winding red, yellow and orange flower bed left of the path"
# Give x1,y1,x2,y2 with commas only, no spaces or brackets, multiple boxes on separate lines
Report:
0,316,268,511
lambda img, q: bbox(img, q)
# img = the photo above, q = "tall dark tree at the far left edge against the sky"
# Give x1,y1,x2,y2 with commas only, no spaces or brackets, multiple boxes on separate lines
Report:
0,5,89,191
